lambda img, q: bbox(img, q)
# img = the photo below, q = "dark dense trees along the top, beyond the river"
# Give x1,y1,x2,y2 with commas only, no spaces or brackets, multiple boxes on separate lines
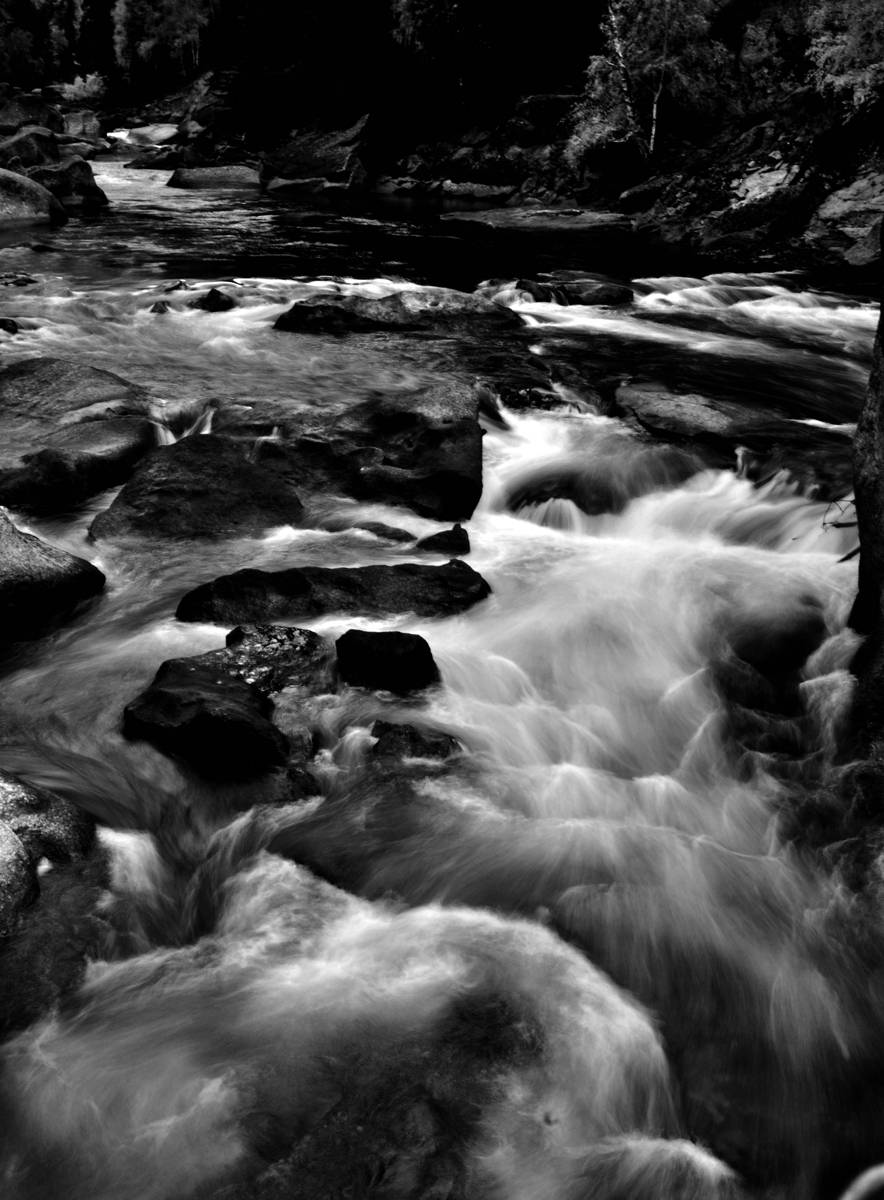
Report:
0,0,884,158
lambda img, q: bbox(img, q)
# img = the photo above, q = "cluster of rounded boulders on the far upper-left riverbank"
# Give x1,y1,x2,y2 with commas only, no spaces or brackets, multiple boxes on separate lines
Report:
0,92,110,228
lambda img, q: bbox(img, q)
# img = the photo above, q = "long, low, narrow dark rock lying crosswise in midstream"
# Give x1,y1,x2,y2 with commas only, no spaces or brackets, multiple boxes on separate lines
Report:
175,560,491,624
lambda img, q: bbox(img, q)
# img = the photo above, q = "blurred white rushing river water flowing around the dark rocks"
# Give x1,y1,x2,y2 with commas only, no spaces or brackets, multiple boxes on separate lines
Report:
0,166,884,1200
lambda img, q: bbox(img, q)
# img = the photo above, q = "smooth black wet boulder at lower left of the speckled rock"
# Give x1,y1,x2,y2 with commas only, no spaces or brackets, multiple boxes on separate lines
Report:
122,655,289,779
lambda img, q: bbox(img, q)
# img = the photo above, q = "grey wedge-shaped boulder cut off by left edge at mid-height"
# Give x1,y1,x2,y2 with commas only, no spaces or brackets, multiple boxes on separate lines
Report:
0,511,104,644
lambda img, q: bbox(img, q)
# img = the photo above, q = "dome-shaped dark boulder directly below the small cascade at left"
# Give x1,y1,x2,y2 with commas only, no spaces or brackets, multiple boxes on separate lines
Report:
90,434,303,542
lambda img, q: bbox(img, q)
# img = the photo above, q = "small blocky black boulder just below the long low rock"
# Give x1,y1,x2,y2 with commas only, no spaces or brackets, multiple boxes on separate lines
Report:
335,629,439,696
